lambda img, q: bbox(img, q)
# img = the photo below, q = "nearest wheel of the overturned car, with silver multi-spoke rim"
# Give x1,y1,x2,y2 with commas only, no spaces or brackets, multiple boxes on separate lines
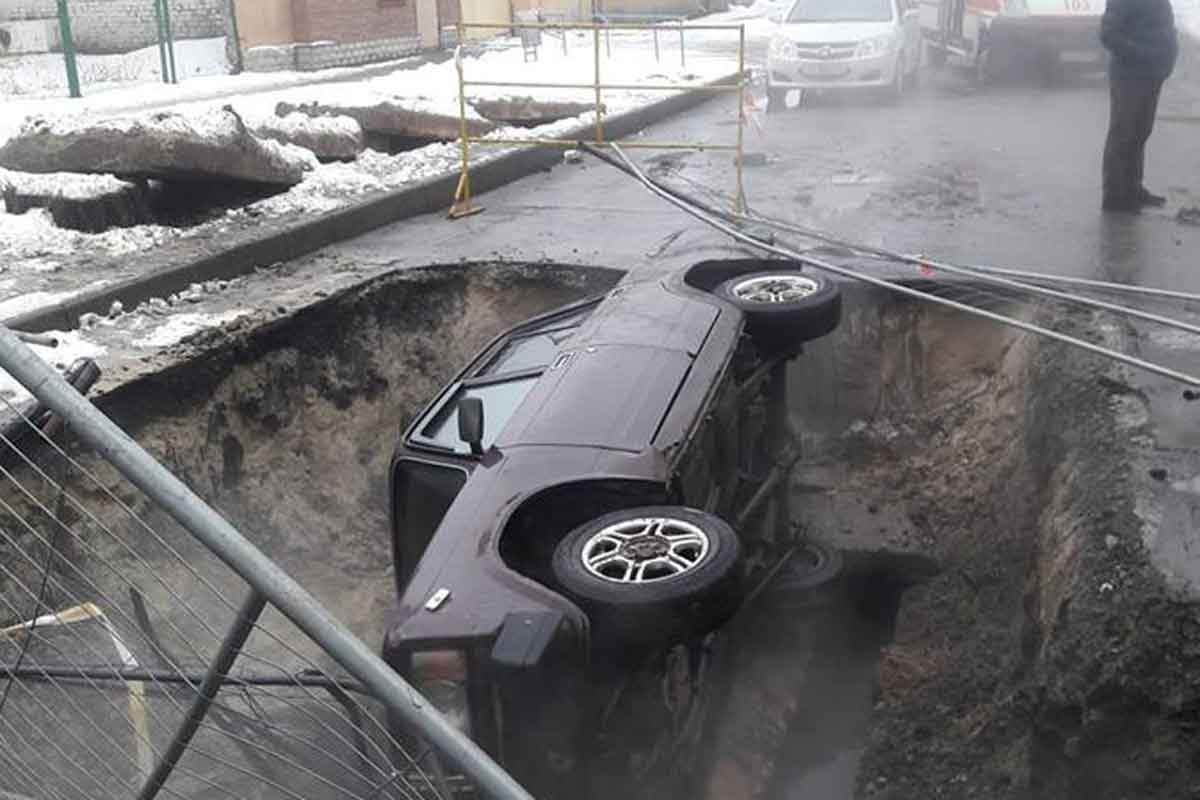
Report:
551,506,742,646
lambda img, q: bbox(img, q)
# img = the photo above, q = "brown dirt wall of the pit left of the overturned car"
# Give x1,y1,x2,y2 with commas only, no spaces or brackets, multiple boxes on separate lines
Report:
0,265,619,671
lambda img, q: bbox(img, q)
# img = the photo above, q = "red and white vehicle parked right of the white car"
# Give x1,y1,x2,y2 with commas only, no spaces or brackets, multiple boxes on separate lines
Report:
919,0,1106,83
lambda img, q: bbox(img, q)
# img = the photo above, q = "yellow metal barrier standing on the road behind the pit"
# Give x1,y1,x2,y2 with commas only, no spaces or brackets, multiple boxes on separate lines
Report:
450,22,746,219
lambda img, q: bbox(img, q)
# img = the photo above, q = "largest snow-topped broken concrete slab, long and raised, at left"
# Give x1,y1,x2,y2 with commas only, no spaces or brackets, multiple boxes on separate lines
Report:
0,109,317,186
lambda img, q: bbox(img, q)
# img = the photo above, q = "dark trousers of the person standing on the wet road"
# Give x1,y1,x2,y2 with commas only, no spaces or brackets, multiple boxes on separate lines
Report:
1104,76,1163,205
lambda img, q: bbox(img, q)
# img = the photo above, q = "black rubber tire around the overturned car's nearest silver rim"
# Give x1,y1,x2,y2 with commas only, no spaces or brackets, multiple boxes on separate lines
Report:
551,506,742,646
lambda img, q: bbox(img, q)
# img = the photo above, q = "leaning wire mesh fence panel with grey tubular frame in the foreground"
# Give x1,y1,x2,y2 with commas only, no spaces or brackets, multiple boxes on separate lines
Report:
0,326,529,800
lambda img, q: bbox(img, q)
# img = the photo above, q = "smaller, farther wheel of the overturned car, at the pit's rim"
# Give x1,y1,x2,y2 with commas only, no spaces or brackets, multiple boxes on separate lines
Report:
716,267,841,345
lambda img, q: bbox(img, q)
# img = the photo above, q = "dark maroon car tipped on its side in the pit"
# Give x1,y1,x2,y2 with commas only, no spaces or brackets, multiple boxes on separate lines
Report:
383,260,841,798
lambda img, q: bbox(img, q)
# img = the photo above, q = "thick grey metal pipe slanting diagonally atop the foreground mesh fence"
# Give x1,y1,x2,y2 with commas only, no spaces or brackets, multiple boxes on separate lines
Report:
0,326,532,800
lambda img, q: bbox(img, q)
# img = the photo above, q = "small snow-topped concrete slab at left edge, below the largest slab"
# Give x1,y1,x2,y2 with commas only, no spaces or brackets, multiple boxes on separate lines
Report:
0,169,154,233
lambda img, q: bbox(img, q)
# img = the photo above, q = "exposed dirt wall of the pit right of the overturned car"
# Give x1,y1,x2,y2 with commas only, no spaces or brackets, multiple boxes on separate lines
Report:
777,289,1200,800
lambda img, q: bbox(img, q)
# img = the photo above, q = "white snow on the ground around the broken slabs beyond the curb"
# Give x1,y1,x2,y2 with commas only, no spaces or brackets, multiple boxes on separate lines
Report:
0,25,736,297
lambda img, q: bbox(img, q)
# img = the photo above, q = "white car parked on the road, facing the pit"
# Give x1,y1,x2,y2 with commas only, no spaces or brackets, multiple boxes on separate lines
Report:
767,0,922,110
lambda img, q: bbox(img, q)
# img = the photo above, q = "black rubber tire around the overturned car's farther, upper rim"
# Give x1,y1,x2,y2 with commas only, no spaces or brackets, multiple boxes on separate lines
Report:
716,267,841,345
